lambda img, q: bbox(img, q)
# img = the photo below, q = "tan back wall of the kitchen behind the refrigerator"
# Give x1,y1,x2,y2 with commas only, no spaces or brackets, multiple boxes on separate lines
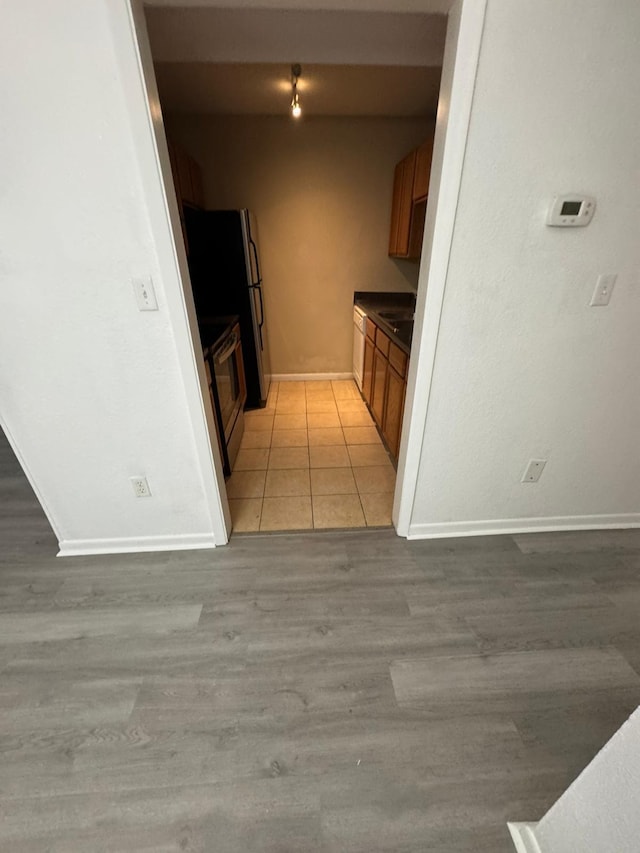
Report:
167,116,432,374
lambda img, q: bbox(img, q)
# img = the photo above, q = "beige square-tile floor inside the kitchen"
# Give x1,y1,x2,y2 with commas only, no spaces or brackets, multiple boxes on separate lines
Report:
227,380,396,533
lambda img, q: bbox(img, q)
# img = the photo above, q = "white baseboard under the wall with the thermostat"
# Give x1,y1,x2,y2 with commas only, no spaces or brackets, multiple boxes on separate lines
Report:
407,513,640,539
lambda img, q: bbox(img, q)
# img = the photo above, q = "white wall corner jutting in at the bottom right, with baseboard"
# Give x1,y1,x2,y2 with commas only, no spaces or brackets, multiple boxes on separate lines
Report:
514,710,640,853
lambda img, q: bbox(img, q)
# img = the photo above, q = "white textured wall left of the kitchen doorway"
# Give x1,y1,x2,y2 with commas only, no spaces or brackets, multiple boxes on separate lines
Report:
0,0,230,553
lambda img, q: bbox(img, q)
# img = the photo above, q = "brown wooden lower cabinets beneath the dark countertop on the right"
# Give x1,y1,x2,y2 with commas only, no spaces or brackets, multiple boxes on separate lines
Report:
362,317,408,459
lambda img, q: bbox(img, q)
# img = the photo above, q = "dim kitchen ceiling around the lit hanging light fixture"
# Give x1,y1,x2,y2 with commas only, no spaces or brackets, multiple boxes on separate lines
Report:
146,6,446,117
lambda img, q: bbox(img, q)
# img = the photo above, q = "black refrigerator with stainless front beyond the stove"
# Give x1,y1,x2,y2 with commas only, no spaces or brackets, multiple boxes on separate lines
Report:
185,208,271,409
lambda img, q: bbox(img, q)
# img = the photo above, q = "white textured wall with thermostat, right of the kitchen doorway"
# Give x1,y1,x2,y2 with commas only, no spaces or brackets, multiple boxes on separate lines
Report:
409,0,640,536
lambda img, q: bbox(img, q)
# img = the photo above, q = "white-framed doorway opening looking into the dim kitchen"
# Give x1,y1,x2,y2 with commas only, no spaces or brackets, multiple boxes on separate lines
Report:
141,6,446,532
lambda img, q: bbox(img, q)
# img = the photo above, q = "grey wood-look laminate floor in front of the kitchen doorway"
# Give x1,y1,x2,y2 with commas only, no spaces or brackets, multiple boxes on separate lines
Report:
0,430,640,853
